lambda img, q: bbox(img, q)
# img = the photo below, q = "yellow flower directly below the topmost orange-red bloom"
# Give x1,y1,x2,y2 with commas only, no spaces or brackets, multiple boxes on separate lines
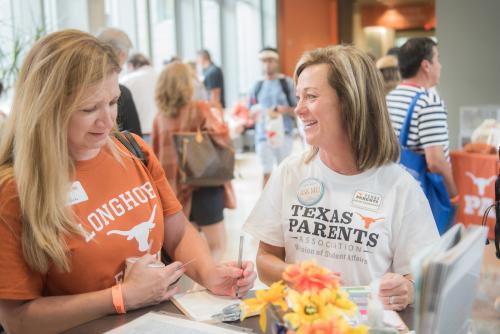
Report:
284,290,335,328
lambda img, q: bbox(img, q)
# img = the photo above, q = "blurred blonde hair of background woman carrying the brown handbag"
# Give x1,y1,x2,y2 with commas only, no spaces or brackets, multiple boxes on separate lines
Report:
155,62,193,118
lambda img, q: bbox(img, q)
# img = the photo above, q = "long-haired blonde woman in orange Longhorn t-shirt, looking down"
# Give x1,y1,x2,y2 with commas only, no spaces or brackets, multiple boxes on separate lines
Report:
0,30,256,333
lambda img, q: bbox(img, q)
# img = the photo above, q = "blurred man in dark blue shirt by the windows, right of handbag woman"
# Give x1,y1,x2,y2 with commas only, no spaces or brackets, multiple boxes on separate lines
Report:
197,50,226,108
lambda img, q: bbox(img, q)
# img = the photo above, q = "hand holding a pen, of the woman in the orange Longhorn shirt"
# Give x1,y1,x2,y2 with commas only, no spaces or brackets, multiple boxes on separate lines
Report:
204,261,257,298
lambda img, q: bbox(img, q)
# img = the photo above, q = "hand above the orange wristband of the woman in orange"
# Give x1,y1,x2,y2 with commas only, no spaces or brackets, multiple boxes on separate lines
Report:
122,254,186,311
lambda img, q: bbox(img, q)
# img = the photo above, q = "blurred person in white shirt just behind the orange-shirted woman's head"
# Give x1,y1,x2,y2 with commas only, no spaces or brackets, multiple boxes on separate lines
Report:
120,53,158,143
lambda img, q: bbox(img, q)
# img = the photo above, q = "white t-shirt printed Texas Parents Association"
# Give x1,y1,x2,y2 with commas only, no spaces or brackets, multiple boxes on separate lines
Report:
243,155,439,285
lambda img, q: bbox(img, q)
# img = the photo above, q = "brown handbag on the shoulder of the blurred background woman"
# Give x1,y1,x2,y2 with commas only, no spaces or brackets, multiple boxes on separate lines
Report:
173,109,235,186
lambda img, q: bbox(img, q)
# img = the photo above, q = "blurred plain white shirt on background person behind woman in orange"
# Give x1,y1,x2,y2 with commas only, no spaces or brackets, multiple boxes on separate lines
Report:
120,65,157,134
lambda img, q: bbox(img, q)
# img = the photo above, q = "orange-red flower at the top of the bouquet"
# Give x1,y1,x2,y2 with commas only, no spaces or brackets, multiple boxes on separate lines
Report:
283,260,339,292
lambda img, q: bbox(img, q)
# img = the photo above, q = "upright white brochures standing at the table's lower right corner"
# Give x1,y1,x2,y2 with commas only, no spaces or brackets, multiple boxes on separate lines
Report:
412,224,488,334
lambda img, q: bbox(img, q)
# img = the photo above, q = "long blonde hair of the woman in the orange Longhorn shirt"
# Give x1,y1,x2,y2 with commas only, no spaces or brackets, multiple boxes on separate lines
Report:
0,30,120,273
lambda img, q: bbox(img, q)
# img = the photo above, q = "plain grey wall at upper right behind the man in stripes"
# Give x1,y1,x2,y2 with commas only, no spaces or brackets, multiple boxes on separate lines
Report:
436,0,500,148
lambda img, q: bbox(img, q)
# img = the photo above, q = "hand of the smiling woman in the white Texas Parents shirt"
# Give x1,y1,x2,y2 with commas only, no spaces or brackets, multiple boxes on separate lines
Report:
379,273,414,311
